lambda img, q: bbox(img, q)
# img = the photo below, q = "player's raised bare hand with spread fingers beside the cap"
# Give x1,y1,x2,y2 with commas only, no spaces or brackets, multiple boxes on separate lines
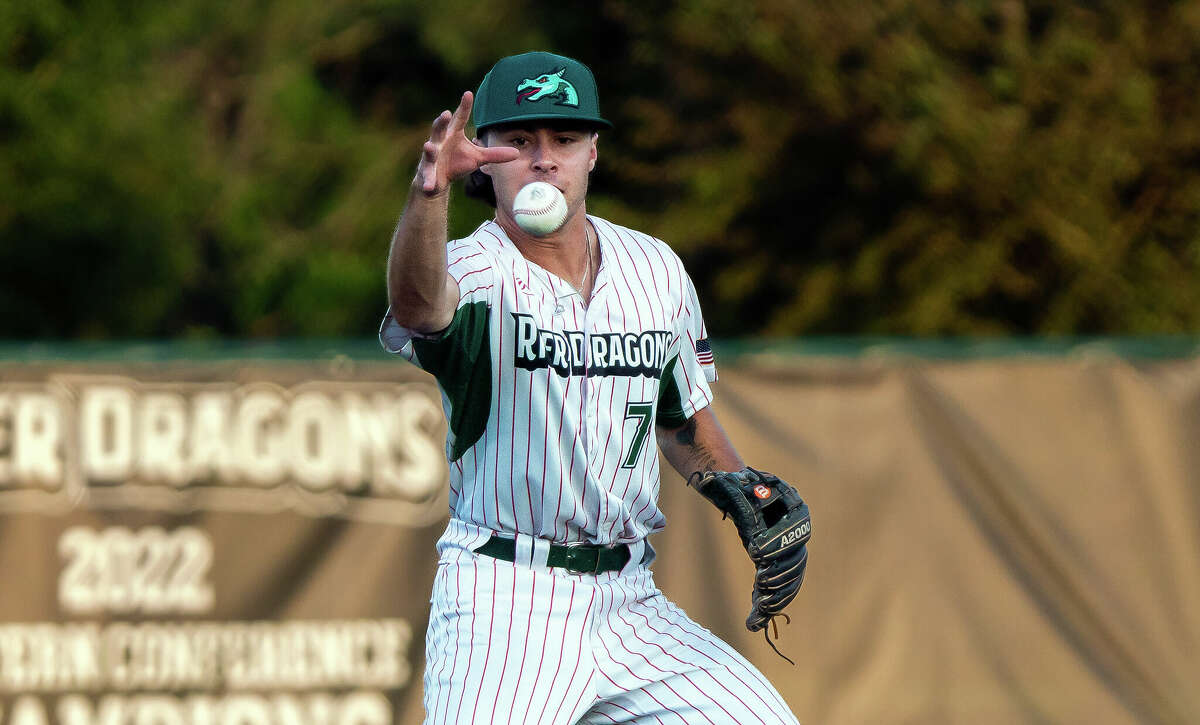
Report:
416,91,521,197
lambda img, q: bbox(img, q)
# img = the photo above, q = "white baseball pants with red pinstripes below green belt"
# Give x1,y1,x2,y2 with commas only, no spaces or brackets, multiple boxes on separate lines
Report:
425,521,797,725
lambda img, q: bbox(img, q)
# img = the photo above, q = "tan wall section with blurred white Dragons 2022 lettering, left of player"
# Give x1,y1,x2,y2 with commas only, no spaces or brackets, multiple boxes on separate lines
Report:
0,361,446,725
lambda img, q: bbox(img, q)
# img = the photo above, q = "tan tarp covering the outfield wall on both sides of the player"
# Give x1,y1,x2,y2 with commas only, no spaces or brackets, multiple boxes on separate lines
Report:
0,358,1200,725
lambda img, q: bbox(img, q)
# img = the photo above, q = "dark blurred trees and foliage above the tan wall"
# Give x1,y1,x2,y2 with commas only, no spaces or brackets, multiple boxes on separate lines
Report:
7,0,1200,338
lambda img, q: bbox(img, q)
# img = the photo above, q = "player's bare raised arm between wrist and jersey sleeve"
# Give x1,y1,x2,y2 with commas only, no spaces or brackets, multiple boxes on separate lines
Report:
388,181,458,332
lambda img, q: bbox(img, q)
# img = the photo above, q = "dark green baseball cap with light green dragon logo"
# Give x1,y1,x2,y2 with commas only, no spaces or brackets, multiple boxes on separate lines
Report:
473,52,612,131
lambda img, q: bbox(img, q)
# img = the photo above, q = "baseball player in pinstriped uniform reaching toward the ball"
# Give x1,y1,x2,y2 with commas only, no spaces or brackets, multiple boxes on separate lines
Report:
379,53,809,724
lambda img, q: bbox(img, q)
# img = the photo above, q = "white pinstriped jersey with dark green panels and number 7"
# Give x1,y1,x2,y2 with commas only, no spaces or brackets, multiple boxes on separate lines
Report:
379,216,716,545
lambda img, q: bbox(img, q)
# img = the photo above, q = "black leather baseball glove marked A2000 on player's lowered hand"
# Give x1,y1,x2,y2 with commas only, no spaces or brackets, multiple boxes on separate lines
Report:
689,468,812,657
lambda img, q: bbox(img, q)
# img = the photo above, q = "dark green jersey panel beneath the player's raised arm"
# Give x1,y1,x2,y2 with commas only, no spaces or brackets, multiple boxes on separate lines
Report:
413,302,492,463
